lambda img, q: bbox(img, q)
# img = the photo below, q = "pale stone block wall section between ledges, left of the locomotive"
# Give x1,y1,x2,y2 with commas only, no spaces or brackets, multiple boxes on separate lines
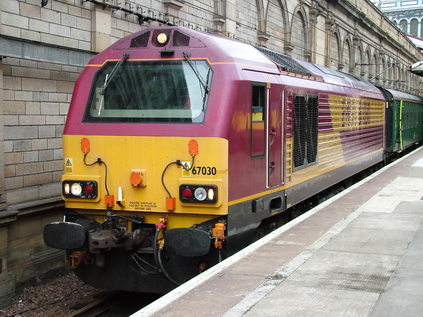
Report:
3,58,81,205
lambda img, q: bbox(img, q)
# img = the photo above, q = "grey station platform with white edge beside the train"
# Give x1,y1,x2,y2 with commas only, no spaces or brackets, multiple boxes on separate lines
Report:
132,147,423,317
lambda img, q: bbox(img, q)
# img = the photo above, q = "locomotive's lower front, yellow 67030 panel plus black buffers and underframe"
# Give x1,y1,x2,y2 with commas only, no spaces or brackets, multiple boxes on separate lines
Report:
44,135,228,292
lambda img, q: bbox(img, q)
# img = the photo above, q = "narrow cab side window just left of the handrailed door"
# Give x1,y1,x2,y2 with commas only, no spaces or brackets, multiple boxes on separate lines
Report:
251,84,266,156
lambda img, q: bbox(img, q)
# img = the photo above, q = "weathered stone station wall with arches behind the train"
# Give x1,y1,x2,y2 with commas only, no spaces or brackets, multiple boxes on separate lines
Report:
0,0,422,307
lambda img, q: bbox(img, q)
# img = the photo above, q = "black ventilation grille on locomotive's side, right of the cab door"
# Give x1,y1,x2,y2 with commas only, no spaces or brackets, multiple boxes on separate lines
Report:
293,96,318,169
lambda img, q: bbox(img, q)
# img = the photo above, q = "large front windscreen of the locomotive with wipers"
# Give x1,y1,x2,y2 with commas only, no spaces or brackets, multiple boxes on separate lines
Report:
84,60,212,123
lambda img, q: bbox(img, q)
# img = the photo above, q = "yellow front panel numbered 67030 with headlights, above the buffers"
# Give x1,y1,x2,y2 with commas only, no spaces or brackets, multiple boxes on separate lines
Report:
62,135,228,228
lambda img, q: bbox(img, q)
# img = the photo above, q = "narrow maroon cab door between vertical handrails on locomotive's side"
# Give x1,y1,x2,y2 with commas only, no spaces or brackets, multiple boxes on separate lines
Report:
265,83,284,188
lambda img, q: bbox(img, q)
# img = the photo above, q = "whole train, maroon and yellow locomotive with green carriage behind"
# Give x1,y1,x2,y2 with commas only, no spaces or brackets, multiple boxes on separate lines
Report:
44,26,423,293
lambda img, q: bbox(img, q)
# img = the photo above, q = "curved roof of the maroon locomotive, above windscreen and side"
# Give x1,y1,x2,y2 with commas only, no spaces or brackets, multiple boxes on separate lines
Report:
99,26,380,93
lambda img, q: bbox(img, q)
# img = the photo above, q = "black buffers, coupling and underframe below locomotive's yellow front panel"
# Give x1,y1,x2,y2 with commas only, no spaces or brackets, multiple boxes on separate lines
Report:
44,211,225,293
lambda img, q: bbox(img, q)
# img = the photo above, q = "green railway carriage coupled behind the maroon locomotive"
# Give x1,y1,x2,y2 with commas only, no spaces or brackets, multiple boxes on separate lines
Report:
382,89,423,153
